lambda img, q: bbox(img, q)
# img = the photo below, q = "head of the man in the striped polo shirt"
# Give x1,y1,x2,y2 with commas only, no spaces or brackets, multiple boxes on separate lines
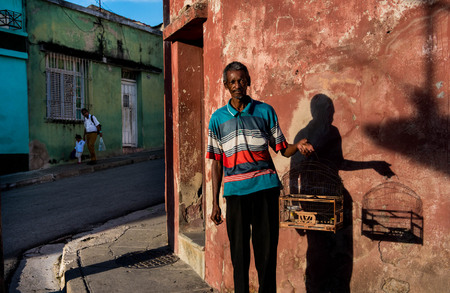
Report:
223,61,251,99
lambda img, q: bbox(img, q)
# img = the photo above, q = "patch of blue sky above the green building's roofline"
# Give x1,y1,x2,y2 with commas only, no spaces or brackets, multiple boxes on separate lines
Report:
66,0,163,26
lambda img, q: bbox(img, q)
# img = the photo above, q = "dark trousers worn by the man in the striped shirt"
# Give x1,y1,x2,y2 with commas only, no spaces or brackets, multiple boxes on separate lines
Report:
225,188,280,293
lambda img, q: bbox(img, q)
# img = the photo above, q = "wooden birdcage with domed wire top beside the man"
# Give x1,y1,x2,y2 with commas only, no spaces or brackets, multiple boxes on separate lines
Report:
280,161,344,232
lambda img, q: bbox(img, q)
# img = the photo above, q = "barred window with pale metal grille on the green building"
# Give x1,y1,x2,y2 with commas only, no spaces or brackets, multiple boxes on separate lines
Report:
45,53,88,121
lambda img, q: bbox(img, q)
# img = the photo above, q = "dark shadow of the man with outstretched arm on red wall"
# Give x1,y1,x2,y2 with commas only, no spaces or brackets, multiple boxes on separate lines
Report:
290,94,395,293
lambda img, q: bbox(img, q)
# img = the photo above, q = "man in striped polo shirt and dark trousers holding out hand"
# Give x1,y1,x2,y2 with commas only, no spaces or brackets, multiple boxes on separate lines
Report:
206,62,314,293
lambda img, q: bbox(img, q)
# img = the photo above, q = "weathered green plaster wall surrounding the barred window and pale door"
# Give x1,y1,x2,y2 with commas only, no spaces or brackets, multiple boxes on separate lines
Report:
27,0,164,168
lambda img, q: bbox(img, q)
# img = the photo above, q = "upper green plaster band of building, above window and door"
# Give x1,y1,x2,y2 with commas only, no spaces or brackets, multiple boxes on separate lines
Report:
27,0,162,68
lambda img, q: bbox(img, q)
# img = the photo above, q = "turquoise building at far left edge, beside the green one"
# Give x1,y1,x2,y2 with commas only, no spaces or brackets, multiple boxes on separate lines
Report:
0,0,29,175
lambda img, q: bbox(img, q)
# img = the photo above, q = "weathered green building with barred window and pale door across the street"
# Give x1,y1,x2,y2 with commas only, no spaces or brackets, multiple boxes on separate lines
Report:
26,0,164,169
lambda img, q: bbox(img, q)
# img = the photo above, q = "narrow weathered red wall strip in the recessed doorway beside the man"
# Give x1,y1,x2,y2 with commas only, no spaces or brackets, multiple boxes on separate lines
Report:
166,42,204,252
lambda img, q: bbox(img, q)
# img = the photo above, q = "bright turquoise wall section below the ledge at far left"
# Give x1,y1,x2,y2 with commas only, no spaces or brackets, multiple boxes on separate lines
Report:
0,53,28,154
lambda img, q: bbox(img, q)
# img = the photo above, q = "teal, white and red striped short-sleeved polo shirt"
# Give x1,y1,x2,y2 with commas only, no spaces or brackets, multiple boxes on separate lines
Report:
206,99,288,196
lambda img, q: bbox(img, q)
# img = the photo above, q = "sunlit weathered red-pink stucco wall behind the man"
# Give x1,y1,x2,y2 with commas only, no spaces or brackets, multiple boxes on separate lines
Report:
166,0,450,292
